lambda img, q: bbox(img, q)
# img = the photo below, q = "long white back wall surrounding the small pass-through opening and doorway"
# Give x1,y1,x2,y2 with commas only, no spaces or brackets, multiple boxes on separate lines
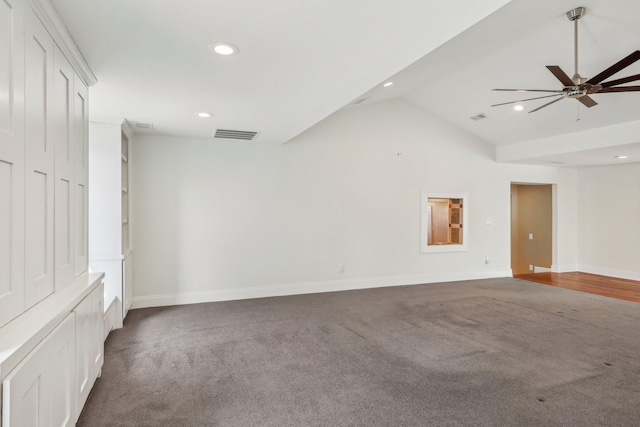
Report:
133,101,577,307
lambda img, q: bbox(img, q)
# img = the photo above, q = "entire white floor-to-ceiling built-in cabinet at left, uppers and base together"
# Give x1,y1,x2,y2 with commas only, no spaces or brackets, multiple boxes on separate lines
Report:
0,0,104,427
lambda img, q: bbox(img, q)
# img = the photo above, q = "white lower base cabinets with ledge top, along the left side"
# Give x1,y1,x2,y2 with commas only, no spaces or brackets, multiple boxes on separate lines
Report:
0,274,104,427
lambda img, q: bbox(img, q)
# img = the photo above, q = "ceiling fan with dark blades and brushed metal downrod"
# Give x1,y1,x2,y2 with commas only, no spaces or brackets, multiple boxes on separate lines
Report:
492,7,640,113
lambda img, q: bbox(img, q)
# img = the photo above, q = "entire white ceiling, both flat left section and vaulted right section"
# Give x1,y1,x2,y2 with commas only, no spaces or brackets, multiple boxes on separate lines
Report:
52,0,640,166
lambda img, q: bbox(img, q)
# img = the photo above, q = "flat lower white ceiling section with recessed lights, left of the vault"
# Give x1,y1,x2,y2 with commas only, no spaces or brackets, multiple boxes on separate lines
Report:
52,0,508,143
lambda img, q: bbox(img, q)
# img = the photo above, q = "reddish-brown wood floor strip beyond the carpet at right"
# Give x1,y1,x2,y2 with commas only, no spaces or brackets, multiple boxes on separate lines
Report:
514,272,640,302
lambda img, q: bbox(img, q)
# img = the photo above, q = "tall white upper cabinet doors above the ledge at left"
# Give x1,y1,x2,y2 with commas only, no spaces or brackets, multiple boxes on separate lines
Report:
0,0,89,327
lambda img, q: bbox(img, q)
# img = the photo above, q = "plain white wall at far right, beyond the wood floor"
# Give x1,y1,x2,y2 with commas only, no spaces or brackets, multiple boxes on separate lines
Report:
578,163,640,280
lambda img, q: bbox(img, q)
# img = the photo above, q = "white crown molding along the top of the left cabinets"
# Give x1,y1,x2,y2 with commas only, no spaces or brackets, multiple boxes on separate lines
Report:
29,0,98,86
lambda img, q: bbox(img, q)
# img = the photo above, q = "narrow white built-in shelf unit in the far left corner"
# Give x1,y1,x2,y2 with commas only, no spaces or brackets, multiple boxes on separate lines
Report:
89,117,133,332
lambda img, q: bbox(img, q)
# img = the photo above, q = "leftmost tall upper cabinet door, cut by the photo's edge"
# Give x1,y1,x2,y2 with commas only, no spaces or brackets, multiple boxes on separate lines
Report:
0,0,24,326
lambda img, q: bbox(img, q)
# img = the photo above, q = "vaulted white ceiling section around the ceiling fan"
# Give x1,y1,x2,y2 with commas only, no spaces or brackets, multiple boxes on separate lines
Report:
350,0,640,167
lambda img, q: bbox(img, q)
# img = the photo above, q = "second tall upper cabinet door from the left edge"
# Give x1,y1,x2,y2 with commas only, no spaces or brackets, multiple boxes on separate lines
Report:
24,7,54,308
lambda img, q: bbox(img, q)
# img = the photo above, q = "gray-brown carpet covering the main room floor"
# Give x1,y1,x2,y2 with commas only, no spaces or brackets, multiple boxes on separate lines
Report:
78,278,640,427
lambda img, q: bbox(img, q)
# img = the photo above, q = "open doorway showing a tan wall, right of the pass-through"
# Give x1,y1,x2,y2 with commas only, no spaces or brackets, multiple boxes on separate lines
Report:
511,183,553,276
